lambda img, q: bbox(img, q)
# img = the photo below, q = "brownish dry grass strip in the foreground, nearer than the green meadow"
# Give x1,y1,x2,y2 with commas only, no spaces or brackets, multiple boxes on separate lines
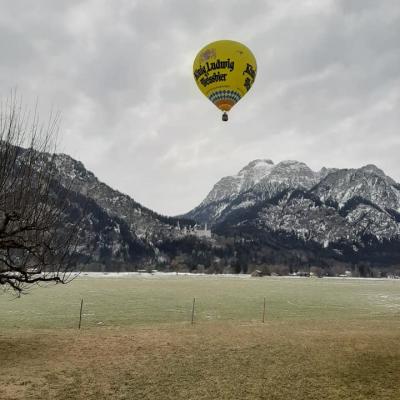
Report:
0,320,400,400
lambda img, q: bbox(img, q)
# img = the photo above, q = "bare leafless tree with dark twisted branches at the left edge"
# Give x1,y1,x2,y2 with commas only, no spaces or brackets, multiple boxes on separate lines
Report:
0,95,79,293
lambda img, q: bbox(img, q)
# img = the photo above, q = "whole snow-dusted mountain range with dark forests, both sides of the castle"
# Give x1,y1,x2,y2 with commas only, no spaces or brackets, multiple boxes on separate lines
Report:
10,142,400,270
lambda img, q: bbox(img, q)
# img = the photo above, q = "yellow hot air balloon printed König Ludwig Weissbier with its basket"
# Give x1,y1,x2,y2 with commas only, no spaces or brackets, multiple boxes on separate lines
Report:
193,40,257,121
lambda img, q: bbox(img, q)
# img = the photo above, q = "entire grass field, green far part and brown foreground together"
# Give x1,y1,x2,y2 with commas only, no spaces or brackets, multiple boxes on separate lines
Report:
0,274,400,400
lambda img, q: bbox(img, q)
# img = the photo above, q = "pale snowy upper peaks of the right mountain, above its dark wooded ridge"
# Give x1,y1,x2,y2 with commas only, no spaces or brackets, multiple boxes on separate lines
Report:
187,156,400,233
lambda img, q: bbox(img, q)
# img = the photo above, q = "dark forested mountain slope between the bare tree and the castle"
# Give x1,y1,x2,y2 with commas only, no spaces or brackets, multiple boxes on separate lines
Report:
21,153,194,270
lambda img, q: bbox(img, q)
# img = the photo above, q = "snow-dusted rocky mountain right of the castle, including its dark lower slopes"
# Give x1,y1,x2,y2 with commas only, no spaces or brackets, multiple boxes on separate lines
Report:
186,160,400,264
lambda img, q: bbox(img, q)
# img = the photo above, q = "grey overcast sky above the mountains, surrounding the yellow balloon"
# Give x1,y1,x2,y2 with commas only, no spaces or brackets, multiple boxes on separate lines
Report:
0,0,400,215
